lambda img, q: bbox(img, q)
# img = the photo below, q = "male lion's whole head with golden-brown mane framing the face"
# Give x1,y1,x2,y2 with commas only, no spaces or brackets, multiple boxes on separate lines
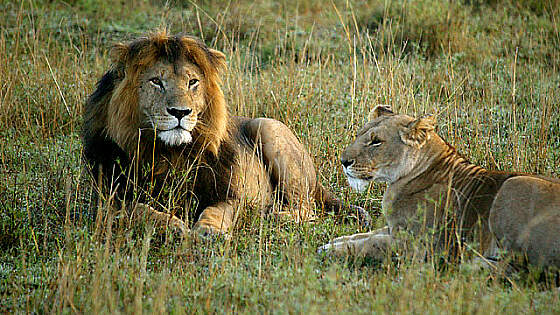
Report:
101,31,228,156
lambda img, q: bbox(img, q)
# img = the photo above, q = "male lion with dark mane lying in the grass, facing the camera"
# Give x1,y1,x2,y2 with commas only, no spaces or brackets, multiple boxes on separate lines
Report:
83,32,364,234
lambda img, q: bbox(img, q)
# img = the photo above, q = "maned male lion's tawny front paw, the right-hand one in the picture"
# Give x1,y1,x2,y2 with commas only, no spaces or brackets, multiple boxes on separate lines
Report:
193,201,234,236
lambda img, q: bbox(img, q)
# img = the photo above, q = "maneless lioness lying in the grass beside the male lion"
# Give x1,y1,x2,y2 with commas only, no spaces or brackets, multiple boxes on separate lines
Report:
320,106,560,267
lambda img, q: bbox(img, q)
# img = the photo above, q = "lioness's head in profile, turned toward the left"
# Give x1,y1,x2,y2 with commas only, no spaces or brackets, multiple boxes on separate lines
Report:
342,106,434,191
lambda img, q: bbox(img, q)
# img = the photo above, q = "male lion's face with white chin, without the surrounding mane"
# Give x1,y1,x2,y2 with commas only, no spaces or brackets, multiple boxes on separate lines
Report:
138,61,205,146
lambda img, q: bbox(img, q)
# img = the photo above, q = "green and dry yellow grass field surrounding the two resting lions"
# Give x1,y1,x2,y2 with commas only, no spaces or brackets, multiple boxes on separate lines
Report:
0,0,560,314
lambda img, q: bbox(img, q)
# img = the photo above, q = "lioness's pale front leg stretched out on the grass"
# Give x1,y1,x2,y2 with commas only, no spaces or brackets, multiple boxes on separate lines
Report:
318,227,394,259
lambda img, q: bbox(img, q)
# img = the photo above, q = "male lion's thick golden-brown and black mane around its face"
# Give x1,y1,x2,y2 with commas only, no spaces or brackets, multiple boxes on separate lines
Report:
82,32,232,220
